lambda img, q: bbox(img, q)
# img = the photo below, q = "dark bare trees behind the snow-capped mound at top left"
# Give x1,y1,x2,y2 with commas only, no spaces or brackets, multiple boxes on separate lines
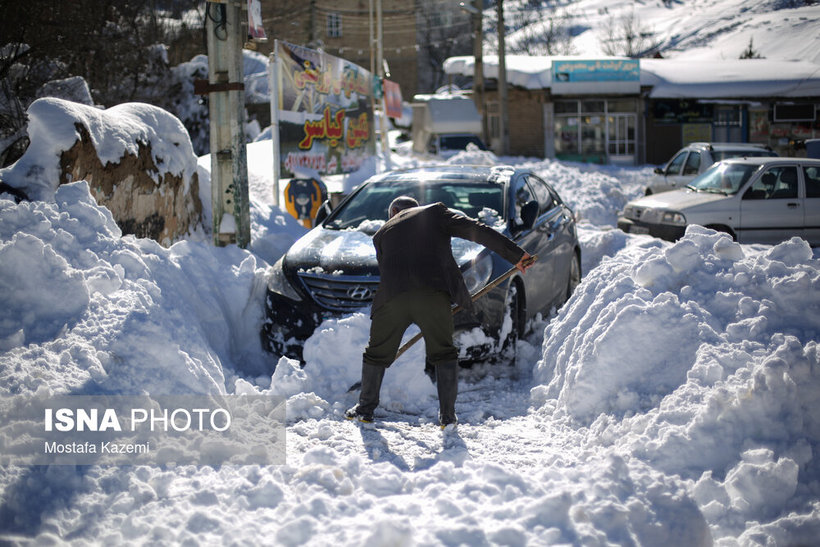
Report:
0,0,203,165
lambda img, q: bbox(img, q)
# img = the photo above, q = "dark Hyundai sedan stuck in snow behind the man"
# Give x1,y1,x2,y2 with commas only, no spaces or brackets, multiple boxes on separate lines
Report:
262,165,581,361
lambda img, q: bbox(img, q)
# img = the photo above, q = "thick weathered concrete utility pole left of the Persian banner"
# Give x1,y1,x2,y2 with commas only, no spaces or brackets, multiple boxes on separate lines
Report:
203,1,251,248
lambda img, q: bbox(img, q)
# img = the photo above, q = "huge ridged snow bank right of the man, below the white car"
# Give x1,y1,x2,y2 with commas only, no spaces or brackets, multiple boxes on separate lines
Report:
531,227,820,541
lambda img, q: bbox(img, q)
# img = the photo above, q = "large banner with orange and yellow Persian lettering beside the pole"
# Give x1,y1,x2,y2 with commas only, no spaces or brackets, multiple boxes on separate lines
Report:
276,42,375,176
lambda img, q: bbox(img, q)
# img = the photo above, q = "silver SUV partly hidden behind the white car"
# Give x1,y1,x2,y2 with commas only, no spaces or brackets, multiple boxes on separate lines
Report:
645,142,777,196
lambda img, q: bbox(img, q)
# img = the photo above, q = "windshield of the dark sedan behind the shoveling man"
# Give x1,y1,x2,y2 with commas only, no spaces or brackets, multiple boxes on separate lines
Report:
325,180,503,230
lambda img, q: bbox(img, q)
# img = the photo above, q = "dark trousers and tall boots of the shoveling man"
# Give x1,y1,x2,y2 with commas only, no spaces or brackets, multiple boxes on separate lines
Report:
359,288,458,419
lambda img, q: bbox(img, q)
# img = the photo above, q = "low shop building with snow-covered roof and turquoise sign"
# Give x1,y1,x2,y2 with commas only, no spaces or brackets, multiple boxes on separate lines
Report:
445,56,820,165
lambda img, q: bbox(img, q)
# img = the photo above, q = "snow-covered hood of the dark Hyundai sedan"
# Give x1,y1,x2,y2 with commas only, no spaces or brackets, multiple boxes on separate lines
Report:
286,227,484,275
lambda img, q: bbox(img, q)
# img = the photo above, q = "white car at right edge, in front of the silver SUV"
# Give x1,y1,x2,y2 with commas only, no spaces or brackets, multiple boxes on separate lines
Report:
618,157,820,246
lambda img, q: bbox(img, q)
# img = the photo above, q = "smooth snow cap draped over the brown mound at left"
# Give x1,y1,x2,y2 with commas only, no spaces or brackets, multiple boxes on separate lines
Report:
0,98,196,200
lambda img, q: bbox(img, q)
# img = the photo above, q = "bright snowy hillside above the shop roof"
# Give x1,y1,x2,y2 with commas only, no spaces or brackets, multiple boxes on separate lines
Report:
496,0,820,64
